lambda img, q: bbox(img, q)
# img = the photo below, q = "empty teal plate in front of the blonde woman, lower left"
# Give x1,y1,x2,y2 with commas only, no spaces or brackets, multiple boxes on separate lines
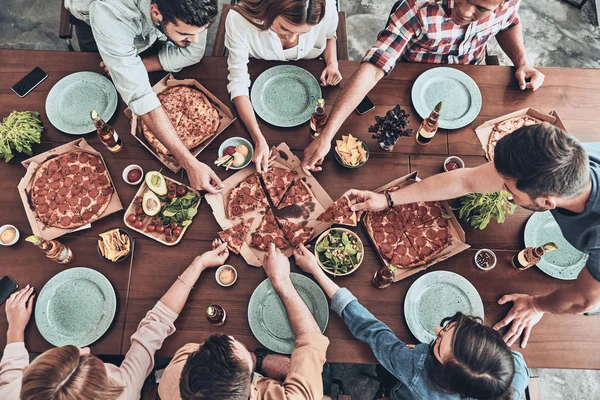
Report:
35,268,117,347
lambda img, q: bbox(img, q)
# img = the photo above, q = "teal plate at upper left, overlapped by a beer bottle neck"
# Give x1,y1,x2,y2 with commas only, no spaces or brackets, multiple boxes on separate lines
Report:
46,71,118,135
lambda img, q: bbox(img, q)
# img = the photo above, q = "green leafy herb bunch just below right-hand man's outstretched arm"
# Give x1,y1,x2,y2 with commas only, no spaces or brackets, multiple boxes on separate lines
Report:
456,191,517,229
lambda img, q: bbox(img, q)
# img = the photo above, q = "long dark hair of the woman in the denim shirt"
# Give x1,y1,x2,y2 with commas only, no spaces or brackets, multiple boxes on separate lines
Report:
425,312,515,400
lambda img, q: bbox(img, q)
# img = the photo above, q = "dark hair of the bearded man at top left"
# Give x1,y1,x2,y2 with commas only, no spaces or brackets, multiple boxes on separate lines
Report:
152,0,219,27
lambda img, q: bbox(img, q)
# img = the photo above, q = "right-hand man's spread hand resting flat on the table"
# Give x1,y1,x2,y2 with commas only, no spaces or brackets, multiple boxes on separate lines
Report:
494,293,544,349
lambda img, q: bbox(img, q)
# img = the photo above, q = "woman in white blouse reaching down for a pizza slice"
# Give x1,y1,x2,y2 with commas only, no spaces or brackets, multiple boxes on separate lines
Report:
225,0,342,172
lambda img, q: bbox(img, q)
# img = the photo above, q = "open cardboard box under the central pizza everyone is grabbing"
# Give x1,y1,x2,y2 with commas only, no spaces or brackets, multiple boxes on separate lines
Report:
204,143,333,267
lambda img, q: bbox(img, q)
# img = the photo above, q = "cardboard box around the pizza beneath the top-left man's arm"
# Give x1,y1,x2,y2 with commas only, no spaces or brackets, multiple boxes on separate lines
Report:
123,74,236,173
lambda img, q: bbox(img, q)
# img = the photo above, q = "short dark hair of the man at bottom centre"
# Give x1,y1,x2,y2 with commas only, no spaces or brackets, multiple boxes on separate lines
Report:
179,335,252,400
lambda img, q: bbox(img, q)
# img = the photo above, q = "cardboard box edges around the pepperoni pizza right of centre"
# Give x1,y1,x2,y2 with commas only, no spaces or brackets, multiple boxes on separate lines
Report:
361,171,471,282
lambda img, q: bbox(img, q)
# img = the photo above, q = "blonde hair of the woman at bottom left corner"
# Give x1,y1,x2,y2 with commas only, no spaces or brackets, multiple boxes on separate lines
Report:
21,346,124,400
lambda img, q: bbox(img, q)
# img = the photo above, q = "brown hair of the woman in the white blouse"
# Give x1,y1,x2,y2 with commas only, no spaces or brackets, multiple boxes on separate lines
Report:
233,0,334,31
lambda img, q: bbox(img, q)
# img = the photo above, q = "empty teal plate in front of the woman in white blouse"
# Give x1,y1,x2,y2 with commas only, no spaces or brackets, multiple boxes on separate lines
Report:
250,65,322,128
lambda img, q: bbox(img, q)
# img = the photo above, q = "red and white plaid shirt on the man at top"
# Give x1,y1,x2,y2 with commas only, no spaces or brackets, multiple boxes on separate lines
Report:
363,0,520,75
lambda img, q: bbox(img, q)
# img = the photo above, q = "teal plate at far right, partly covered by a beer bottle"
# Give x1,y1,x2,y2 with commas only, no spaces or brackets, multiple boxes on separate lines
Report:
525,211,588,280
